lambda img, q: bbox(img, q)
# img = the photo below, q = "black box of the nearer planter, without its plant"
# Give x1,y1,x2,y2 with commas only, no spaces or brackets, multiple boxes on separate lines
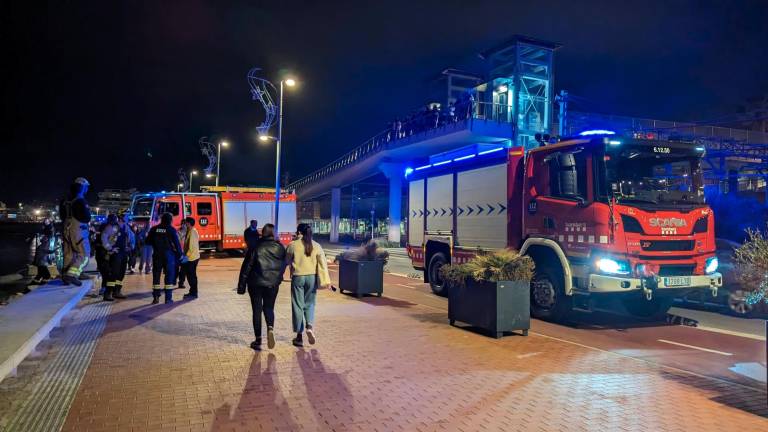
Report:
448,281,531,338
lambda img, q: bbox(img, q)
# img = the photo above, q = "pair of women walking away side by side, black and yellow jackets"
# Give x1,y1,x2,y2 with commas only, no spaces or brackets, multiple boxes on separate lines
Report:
237,221,331,351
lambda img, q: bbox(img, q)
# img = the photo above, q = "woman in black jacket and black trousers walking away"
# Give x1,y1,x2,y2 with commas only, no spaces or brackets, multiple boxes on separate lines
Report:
237,224,285,351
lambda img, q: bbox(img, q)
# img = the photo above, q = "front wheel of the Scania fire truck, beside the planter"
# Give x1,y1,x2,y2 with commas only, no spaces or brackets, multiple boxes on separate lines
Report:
531,266,571,321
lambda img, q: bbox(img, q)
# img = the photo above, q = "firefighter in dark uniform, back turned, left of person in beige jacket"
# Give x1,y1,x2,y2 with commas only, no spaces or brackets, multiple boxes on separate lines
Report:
147,213,181,304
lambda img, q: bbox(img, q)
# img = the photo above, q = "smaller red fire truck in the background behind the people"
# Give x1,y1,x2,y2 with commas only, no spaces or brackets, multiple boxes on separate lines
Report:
131,186,296,251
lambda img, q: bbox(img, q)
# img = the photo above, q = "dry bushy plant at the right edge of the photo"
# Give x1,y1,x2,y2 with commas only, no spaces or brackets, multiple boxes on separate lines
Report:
734,224,768,304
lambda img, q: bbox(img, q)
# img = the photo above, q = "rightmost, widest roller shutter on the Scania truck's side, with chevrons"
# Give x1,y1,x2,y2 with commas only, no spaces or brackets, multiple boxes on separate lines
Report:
456,164,507,249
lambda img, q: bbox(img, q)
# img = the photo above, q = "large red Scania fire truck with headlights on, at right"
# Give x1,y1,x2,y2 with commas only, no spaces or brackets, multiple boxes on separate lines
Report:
406,131,722,320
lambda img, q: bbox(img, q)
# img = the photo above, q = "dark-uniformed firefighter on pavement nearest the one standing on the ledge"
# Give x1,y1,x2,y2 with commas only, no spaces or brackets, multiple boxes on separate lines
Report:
101,212,136,301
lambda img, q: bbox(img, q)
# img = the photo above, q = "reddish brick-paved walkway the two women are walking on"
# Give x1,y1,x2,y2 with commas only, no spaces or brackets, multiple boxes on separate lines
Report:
46,259,768,432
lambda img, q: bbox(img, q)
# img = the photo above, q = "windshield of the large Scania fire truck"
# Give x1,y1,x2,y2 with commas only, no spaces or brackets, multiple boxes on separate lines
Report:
600,145,704,206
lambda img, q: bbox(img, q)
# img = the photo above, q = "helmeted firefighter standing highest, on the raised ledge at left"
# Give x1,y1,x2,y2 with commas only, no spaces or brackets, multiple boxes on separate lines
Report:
59,177,91,286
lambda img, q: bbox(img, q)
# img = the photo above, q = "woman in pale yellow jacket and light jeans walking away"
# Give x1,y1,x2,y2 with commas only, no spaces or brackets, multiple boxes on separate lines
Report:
286,224,331,347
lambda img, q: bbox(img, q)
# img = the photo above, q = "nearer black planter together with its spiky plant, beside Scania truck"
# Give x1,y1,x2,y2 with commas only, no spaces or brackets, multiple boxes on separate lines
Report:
441,249,534,338
